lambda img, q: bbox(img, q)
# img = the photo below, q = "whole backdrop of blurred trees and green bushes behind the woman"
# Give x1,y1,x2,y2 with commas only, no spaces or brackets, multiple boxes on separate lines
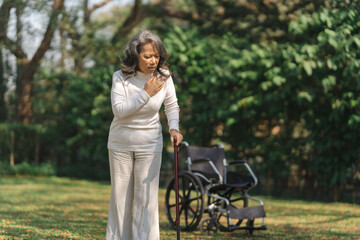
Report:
0,0,360,206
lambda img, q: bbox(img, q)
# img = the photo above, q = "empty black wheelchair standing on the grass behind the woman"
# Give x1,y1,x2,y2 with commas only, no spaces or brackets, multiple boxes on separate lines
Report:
165,142,266,236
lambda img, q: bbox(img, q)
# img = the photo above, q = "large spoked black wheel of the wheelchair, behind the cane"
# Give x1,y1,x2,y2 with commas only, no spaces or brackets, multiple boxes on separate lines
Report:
165,171,204,231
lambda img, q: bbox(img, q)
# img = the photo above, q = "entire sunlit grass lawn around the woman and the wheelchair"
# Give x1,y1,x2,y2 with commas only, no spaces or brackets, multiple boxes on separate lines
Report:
0,177,360,239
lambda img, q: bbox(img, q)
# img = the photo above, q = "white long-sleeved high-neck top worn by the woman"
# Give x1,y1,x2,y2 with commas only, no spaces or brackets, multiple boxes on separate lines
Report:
108,71,179,152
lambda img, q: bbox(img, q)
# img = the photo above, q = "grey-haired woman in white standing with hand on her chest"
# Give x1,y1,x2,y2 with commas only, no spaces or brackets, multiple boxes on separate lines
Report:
106,31,183,240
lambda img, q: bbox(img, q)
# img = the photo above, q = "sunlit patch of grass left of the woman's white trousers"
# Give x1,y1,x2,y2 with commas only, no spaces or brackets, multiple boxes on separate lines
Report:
0,178,110,239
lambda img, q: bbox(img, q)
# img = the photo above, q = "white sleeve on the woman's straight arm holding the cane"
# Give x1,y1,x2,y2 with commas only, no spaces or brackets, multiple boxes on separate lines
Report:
164,77,180,131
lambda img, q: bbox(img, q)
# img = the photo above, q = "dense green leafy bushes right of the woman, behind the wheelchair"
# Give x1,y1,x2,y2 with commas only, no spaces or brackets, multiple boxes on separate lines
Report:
165,2,360,200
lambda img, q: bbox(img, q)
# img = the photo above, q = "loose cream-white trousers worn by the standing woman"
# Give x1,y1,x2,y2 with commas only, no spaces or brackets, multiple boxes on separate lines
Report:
106,149,161,240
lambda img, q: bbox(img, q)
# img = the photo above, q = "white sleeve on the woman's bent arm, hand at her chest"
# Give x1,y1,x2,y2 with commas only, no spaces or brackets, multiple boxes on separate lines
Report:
111,73,150,118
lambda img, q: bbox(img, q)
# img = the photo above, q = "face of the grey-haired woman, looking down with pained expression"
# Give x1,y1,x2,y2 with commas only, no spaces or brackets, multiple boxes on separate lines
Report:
138,43,160,74
